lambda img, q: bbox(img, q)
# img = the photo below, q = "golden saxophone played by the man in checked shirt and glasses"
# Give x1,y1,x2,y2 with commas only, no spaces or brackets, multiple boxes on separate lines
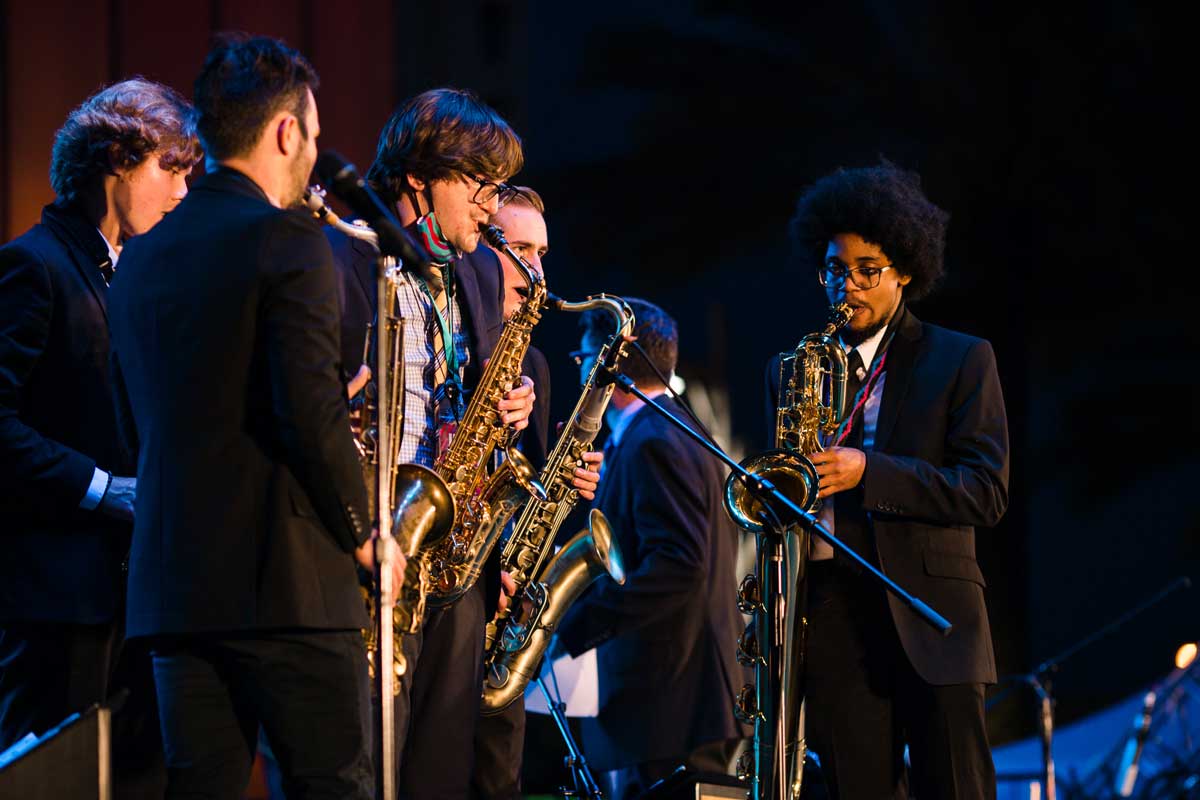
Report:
421,225,547,606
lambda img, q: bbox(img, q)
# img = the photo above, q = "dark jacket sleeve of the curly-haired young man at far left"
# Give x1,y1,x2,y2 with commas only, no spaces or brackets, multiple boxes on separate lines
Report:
0,247,96,509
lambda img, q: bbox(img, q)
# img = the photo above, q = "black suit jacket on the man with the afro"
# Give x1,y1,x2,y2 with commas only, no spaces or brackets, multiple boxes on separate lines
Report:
767,311,1008,685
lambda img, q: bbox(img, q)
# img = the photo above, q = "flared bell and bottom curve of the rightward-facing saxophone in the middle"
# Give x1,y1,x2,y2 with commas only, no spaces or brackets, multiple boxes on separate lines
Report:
480,509,625,716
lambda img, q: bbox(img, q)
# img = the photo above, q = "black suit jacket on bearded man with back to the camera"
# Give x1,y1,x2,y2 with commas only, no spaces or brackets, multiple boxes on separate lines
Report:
110,168,370,636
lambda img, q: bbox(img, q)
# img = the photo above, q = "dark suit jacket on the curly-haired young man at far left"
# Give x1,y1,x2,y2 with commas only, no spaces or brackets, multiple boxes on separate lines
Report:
0,204,133,624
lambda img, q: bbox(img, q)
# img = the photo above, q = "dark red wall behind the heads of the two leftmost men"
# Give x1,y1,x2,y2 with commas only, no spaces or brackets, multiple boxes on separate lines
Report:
0,0,398,241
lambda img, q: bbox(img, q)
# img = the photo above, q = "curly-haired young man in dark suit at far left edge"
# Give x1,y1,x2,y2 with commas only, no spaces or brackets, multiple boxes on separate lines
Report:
0,79,200,796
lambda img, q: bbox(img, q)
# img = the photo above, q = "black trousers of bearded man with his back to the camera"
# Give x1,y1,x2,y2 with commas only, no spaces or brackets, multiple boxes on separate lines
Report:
152,631,373,800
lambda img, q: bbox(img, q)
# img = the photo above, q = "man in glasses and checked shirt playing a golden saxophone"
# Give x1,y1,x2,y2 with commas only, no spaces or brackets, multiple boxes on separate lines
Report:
328,89,534,798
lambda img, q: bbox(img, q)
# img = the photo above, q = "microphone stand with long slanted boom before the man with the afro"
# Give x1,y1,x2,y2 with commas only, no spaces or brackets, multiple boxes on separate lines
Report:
598,368,952,800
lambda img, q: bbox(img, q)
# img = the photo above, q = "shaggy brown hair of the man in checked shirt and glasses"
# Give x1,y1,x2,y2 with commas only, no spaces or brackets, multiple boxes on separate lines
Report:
367,89,524,203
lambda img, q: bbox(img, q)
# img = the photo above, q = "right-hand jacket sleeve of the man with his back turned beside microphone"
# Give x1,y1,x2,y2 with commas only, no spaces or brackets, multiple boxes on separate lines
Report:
259,213,371,552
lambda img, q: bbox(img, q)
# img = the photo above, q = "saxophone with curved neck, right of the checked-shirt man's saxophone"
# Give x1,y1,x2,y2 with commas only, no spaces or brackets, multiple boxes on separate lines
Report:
482,294,635,715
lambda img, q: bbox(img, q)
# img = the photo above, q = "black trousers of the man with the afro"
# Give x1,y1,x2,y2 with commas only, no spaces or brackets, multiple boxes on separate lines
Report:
805,561,996,800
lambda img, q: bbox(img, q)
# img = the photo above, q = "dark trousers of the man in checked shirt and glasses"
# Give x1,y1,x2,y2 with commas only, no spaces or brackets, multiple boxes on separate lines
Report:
391,579,484,800
